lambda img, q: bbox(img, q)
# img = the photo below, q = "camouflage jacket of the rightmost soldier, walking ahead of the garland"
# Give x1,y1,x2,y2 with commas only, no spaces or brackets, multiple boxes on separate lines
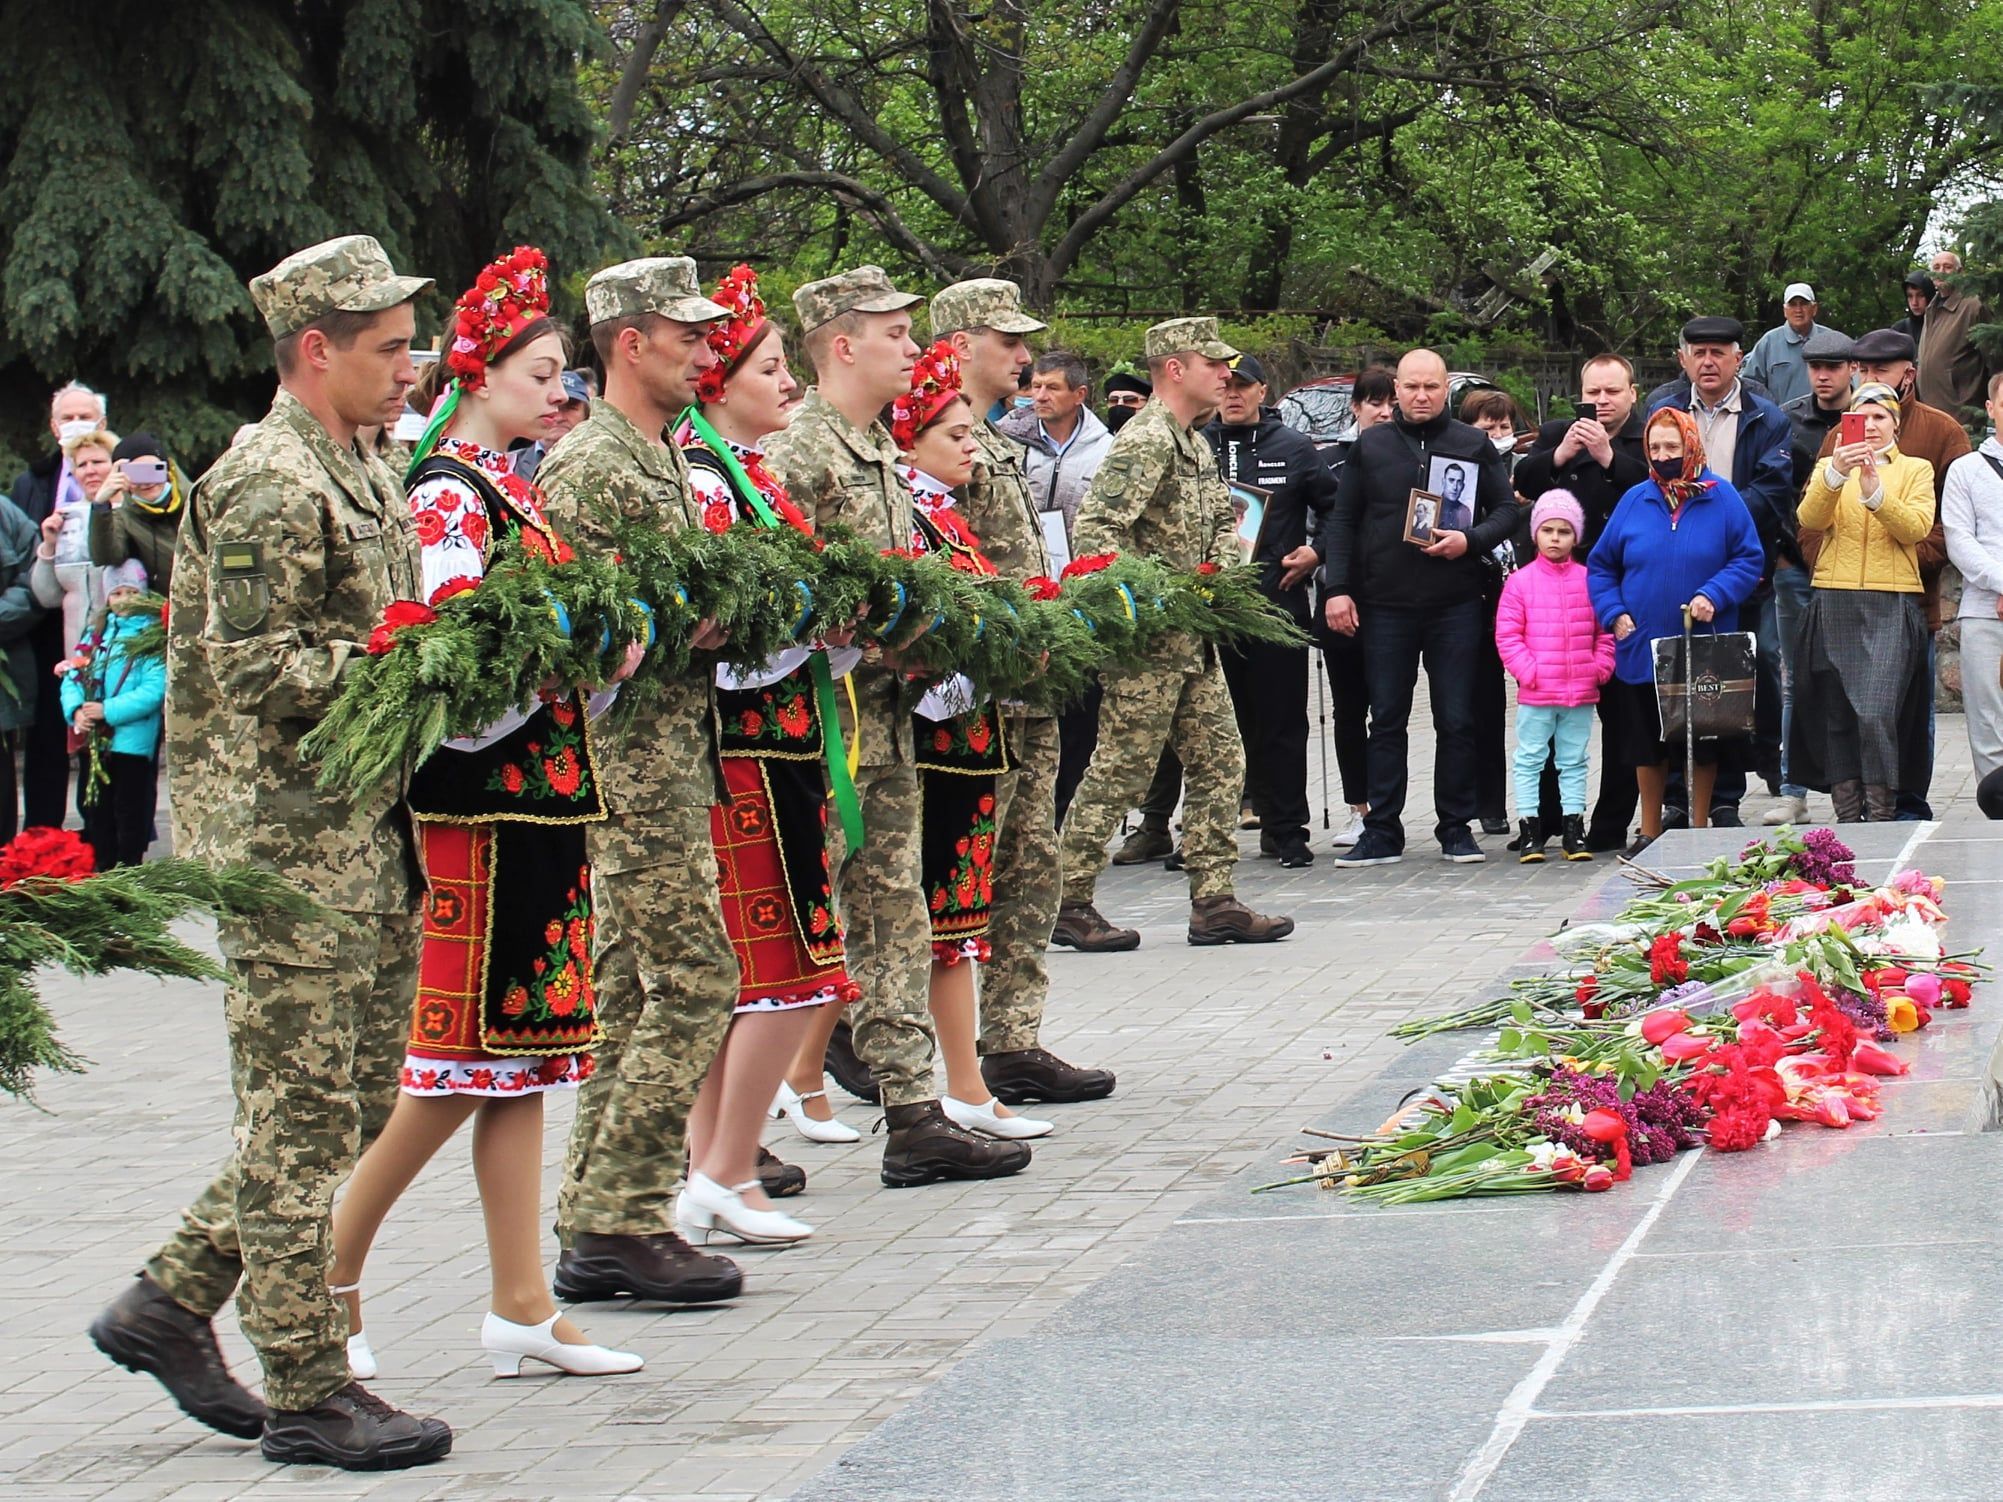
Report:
1074,399,1238,673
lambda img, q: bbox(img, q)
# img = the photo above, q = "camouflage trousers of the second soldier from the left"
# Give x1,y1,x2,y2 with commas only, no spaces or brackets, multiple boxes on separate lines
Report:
557,807,737,1238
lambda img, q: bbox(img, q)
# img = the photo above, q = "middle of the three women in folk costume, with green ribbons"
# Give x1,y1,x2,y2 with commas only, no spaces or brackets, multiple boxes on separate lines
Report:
675,266,857,1244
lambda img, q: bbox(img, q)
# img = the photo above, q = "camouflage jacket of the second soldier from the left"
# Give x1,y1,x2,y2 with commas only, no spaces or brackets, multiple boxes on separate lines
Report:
535,401,723,817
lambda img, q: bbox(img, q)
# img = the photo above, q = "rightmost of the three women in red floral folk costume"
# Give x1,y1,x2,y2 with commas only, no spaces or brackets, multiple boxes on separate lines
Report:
889,340,1052,1140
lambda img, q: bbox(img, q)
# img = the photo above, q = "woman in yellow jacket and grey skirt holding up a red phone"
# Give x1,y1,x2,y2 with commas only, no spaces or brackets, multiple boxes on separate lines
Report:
1787,381,1933,823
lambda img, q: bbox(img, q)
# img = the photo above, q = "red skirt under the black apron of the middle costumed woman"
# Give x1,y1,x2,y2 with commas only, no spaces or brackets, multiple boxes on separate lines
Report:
709,757,861,1011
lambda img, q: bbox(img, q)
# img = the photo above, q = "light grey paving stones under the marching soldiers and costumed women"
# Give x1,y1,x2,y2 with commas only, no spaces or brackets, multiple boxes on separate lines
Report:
0,696,1971,1502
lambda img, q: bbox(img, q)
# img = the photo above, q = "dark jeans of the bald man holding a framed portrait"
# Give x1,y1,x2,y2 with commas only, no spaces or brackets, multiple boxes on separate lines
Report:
1360,599,1488,849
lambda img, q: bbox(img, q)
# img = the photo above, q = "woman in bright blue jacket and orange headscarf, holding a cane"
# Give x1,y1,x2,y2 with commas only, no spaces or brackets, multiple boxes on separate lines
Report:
1586,407,1767,843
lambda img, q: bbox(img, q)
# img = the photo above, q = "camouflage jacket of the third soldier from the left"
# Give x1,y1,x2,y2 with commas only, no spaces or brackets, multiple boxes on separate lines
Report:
765,389,917,767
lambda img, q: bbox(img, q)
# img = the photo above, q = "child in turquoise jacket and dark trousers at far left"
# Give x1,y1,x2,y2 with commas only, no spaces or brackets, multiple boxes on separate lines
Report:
62,559,166,871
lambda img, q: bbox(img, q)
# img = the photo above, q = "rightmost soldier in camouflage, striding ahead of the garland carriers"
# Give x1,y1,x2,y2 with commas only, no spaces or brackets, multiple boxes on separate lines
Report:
1052,318,1294,951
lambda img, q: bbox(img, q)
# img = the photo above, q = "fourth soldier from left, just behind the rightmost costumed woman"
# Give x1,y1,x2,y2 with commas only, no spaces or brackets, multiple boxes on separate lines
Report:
931,278,1114,1105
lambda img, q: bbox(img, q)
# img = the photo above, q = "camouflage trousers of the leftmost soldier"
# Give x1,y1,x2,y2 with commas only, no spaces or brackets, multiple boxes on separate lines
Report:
146,913,419,1412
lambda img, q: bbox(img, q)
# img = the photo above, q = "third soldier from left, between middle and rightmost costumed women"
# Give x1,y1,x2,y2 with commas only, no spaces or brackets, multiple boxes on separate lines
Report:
765,266,1030,1188
